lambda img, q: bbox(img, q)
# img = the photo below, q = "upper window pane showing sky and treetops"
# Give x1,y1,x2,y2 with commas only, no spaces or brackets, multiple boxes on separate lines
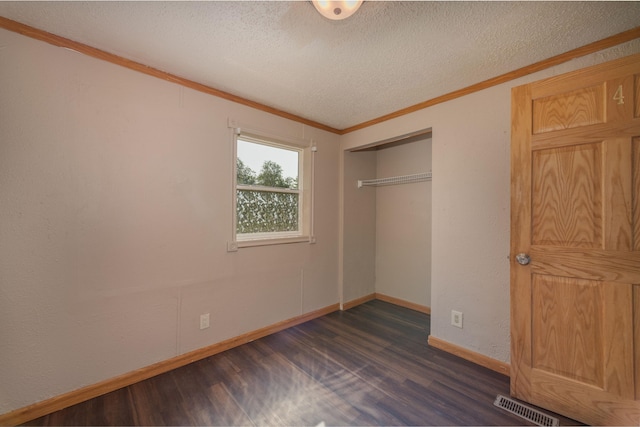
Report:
237,138,299,188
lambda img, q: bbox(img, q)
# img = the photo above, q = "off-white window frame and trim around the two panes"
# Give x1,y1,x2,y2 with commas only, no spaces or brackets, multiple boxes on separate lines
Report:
227,126,316,252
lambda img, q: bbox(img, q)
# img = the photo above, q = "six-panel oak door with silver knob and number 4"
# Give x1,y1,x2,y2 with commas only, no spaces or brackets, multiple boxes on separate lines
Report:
511,55,640,425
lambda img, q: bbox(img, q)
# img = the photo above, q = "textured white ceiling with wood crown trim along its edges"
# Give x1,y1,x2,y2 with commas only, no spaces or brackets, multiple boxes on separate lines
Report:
0,1,640,129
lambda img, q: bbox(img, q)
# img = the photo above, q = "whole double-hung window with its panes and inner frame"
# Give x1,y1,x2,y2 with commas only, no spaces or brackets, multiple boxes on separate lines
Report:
232,131,311,249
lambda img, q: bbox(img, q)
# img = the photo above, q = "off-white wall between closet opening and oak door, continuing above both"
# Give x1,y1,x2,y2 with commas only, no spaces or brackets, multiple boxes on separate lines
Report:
341,40,640,362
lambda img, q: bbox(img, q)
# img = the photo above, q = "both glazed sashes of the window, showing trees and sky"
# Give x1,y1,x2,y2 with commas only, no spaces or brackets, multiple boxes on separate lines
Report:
236,136,302,240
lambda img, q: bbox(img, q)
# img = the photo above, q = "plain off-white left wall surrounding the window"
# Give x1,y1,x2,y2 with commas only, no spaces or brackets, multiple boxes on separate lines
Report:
0,29,340,413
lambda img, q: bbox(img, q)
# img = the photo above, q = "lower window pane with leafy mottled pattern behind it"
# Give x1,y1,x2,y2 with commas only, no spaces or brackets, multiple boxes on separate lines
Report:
236,190,299,234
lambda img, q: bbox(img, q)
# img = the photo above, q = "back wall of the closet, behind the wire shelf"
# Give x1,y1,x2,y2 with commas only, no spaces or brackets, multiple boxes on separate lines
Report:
372,137,431,307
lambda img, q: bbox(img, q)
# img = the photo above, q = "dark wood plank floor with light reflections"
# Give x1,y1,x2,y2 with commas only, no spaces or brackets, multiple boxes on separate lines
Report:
23,301,575,426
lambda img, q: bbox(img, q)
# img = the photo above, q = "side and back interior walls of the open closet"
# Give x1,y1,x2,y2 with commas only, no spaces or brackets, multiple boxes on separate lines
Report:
343,134,437,307
